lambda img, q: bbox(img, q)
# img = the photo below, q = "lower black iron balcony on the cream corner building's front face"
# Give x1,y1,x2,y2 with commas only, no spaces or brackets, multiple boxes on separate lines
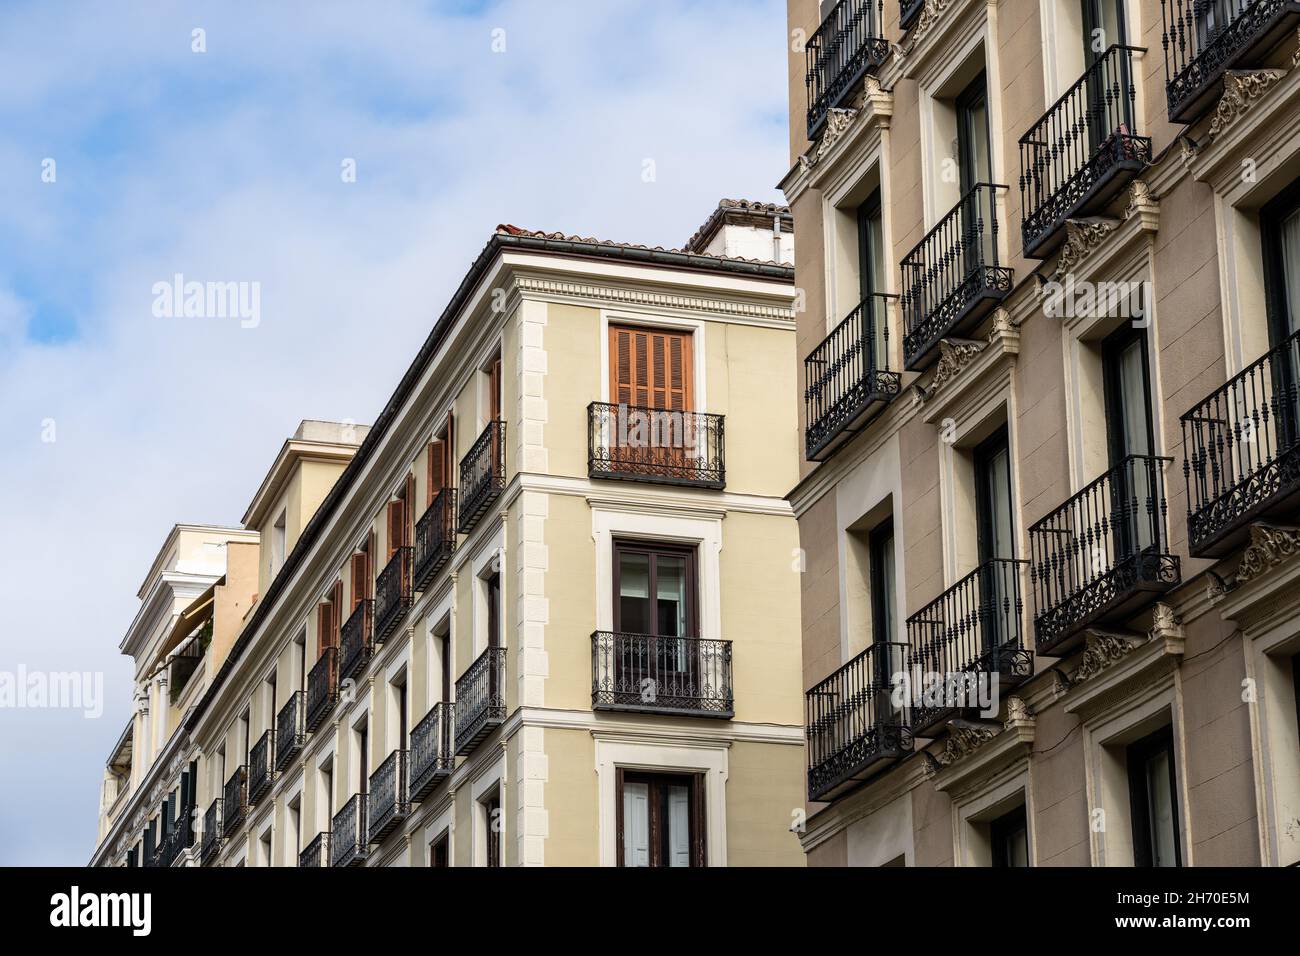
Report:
592,631,736,718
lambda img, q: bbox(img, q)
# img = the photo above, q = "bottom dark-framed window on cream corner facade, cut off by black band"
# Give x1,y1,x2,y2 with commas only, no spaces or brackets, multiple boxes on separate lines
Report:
618,769,705,866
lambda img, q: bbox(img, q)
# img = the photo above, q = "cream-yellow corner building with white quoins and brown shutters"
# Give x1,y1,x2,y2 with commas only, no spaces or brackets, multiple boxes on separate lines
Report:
96,200,803,866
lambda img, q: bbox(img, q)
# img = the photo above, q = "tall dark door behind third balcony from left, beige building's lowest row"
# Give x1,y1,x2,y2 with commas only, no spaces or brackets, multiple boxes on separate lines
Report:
1101,325,1161,556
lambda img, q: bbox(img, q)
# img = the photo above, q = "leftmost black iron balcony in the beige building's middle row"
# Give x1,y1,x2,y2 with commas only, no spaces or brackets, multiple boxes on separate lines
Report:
803,294,901,462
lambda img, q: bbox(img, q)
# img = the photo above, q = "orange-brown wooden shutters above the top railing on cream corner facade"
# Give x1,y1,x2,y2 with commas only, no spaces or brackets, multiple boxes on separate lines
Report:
610,325,693,411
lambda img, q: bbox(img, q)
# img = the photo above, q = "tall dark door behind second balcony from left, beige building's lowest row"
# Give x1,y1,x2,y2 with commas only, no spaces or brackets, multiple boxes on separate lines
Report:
975,427,1019,658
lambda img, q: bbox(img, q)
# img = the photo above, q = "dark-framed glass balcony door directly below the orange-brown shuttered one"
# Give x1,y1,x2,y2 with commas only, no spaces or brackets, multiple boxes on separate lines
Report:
614,541,698,702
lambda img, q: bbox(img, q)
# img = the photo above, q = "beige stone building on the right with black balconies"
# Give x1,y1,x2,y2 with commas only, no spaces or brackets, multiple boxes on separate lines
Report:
781,0,1300,866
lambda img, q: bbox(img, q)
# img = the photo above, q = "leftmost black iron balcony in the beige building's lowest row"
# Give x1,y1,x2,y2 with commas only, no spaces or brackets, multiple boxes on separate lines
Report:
805,643,913,800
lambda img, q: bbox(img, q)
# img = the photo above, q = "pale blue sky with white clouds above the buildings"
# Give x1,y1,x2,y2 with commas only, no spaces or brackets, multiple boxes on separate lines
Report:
0,0,789,864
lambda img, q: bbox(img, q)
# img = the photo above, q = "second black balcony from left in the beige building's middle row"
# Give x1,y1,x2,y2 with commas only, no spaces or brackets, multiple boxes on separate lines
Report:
902,182,1013,372
